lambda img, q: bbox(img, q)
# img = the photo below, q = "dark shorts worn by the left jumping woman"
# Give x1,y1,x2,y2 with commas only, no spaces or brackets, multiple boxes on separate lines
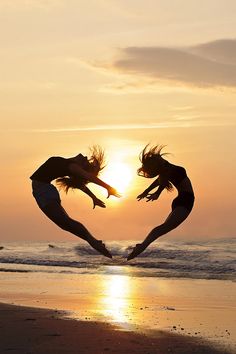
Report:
32,180,61,209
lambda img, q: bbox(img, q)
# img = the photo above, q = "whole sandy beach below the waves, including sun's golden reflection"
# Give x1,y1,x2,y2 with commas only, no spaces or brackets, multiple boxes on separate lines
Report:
0,267,236,354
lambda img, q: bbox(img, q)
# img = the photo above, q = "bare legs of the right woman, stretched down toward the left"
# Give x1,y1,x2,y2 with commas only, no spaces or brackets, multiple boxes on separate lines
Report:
127,206,190,260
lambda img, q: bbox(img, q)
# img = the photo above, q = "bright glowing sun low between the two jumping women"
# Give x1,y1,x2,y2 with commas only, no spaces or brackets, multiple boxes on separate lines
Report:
102,161,133,193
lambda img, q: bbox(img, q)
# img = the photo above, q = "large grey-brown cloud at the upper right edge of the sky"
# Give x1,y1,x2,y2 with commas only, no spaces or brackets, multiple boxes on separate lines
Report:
95,39,236,88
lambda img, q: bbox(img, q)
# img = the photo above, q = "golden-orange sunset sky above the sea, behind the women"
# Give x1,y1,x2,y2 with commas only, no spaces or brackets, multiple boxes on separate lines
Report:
0,0,236,241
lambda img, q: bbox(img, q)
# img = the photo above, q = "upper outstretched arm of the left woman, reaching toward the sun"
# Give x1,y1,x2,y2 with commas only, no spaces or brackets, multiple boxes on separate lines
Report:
69,163,120,198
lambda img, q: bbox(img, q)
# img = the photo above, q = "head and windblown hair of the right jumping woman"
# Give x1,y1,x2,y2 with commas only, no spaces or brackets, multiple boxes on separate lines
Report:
137,144,173,191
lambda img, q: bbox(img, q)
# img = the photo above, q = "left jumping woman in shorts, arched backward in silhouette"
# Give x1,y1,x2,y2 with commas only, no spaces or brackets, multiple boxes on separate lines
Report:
30,147,120,258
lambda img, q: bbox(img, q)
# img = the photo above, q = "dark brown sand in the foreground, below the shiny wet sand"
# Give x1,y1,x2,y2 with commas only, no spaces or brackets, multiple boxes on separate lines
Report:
0,303,230,354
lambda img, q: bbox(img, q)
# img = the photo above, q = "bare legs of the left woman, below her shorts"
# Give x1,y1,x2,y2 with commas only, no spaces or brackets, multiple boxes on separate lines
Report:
42,201,112,258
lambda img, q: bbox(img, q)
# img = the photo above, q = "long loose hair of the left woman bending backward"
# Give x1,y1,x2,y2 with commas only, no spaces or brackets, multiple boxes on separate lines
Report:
56,145,105,193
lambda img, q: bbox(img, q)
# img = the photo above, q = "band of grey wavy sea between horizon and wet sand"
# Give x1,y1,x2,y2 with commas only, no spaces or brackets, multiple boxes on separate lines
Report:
0,238,236,281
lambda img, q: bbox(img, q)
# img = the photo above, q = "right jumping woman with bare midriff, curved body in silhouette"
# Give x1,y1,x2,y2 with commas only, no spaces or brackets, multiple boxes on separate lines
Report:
127,145,194,260
